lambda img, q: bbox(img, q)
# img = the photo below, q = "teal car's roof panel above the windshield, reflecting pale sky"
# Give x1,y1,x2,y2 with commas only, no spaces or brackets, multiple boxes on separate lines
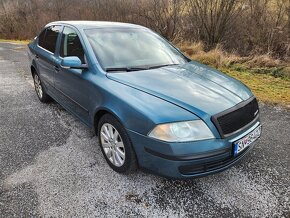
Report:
46,20,145,29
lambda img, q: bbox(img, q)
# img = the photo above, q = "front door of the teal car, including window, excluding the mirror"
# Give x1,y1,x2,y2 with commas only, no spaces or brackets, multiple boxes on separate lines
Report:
55,26,91,124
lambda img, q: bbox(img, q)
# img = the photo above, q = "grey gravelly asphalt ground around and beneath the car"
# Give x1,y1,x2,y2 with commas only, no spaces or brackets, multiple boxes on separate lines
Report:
0,43,290,218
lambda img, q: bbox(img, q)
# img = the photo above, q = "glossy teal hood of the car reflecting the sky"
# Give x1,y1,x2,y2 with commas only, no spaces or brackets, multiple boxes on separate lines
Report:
107,61,252,117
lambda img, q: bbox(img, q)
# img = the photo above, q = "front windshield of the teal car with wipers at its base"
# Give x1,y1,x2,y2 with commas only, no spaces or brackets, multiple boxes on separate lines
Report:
85,28,188,72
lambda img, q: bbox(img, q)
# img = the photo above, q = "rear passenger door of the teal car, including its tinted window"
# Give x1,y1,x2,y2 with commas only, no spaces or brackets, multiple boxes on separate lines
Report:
35,25,62,92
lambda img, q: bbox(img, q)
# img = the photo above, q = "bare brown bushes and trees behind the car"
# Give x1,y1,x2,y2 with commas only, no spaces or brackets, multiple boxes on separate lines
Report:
0,0,290,58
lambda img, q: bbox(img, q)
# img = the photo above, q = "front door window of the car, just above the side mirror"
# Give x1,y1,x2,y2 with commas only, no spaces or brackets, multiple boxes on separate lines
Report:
59,27,85,63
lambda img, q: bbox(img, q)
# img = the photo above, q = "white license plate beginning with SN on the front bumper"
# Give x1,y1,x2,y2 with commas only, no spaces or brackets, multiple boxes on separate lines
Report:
234,126,262,156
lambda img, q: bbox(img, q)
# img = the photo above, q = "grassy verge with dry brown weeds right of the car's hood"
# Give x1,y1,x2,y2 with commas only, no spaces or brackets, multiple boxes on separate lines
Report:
179,43,290,108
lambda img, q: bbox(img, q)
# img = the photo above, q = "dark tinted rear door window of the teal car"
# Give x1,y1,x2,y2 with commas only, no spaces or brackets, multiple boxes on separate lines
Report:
38,26,61,53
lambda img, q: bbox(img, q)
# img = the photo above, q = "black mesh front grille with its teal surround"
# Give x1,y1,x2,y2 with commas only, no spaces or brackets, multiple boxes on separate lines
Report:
212,98,259,137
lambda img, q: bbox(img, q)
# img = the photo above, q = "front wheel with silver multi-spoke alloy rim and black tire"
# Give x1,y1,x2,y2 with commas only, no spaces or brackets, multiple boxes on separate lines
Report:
98,114,138,174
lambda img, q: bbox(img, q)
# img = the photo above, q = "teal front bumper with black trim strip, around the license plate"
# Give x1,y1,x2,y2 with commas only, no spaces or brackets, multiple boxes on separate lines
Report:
128,121,260,179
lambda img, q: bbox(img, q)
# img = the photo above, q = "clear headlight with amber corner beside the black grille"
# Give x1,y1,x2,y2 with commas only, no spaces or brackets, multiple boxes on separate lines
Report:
149,120,214,142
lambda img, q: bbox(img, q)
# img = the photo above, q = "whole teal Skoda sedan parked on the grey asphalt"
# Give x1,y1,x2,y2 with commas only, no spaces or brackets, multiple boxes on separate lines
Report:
28,21,261,179
